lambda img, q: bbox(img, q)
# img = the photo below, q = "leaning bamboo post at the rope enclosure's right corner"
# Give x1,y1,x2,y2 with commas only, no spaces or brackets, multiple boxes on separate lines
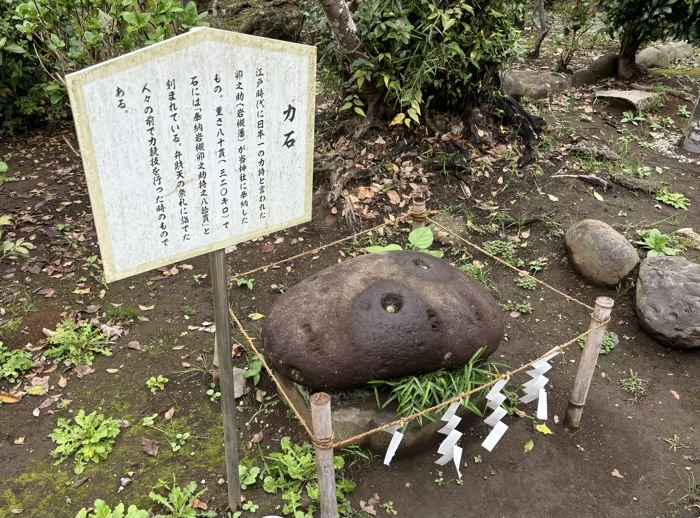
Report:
564,297,615,430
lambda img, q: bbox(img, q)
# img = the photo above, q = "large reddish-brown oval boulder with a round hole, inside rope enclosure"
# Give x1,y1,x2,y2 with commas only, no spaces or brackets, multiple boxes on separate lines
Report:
263,251,503,390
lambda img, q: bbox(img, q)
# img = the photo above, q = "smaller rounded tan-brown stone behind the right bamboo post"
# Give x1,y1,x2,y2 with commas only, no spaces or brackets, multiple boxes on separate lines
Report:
565,219,639,286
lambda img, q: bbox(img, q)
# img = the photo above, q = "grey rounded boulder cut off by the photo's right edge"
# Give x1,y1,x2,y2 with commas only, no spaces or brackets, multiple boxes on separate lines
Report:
635,256,700,349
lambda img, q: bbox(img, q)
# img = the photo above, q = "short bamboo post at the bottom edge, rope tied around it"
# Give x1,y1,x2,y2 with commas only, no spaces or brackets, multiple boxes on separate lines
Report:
311,392,338,518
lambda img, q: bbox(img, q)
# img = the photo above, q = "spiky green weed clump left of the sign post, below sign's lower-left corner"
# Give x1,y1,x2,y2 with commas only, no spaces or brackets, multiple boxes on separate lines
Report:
44,318,113,365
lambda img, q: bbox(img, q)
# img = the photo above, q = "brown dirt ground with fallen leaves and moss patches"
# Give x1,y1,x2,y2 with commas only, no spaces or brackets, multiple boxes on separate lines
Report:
0,8,700,518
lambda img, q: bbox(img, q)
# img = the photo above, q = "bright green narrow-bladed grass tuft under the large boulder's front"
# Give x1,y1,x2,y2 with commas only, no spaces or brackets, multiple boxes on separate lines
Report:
369,348,517,422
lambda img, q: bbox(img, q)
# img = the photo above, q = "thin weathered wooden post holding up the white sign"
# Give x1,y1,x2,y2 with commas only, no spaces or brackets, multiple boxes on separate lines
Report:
209,250,241,511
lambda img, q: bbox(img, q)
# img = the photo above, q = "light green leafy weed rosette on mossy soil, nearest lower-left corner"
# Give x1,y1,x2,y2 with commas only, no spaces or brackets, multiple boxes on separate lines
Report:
49,409,119,474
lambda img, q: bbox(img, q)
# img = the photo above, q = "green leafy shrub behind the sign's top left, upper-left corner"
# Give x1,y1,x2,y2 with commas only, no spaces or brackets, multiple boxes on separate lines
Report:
0,0,206,130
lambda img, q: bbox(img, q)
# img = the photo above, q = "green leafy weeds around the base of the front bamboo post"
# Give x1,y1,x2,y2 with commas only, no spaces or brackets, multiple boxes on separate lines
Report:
263,437,355,518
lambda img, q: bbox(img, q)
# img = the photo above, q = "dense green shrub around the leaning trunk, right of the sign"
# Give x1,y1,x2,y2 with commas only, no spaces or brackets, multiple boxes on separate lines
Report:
312,0,522,125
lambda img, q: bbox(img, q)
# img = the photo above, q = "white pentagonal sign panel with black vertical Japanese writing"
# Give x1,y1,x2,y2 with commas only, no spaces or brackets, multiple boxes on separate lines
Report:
67,28,316,282
